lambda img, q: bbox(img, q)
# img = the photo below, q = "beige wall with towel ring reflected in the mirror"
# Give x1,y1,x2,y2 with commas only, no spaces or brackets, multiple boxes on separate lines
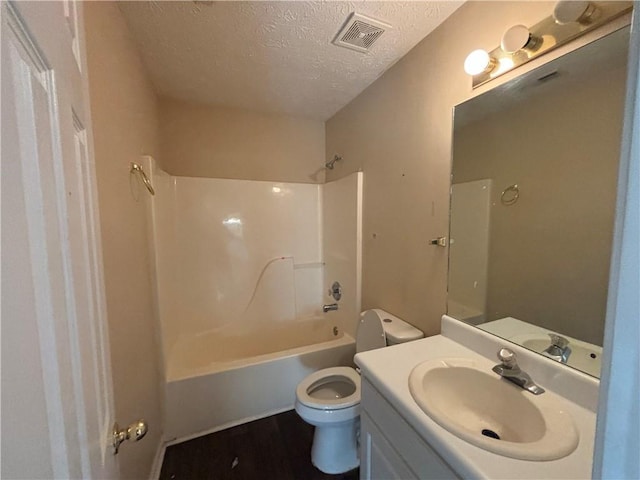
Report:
453,63,626,345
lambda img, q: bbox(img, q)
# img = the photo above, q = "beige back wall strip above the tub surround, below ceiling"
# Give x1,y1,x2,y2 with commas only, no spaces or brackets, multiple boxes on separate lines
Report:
160,98,325,183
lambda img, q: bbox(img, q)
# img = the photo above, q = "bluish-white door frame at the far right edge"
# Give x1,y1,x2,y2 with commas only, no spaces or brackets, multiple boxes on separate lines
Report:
593,9,640,479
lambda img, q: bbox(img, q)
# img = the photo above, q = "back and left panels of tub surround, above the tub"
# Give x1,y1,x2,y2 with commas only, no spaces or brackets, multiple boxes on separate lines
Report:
149,169,322,356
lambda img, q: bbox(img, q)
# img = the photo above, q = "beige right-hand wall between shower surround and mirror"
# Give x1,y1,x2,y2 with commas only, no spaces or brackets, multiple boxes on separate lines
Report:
326,2,624,335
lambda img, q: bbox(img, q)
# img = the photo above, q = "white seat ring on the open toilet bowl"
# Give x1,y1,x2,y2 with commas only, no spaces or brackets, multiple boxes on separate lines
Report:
296,367,360,410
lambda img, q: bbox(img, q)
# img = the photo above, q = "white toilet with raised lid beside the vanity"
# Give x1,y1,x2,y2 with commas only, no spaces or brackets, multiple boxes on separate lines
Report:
295,308,424,474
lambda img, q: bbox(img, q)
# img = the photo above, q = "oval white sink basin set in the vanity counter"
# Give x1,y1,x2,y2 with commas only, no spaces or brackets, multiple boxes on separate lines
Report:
409,358,578,461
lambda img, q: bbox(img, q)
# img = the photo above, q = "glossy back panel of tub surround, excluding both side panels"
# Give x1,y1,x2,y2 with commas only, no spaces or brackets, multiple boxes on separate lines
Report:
171,177,320,335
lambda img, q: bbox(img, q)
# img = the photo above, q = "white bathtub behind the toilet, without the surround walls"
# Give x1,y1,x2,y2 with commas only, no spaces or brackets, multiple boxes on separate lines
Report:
164,319,355,443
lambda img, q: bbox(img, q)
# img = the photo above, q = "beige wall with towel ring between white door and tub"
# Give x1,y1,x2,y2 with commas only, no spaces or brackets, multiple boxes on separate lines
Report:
85,2,162,478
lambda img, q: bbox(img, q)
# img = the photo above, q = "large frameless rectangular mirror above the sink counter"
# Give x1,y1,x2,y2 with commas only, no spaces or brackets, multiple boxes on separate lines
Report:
447,28,629,376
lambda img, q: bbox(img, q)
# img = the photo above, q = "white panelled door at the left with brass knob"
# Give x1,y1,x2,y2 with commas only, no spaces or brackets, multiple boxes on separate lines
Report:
1,1,118,478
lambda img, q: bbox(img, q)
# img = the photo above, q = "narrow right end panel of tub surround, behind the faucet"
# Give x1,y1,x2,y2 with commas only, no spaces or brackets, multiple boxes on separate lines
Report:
322,172,363,337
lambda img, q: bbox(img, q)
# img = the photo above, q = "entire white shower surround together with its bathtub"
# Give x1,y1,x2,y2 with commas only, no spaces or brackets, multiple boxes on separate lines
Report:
144,158,362,441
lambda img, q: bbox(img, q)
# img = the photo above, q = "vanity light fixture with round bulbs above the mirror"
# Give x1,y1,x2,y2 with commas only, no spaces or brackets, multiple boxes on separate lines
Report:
464,0,637,88
